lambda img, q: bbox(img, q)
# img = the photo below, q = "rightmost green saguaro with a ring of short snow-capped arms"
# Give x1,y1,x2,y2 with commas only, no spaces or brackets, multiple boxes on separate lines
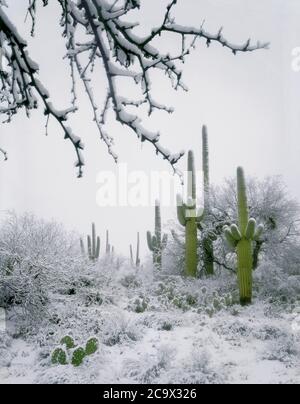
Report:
224,167,264,305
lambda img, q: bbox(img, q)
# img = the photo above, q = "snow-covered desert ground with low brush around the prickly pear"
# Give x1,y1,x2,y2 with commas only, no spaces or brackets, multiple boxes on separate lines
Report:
0,265,300,384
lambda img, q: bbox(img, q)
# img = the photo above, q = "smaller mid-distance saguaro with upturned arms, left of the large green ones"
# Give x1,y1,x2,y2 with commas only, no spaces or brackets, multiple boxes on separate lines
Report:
147,201,168,269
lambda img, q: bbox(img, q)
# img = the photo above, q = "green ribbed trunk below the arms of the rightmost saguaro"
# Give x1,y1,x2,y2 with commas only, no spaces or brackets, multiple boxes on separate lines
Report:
237,239,253,305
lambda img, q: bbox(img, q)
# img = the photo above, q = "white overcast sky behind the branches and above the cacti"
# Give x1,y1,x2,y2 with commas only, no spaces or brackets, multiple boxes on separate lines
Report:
0,0,300,253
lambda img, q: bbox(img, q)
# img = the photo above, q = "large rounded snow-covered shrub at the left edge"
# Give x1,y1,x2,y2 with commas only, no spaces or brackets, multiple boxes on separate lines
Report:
0,213,85,321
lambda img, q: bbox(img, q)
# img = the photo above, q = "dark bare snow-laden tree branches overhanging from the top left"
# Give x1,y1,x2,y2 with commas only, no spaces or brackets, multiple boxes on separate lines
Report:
0,0,268,176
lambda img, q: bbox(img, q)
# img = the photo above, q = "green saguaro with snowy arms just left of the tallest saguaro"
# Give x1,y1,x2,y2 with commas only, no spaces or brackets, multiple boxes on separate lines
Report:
177,151,203,277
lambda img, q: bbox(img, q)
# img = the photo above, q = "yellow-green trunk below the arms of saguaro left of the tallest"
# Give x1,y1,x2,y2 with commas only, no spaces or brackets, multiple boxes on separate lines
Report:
185,218,198,278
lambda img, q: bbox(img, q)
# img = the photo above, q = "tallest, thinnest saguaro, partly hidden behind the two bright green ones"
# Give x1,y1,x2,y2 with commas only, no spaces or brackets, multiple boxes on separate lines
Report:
199,126,214,275
